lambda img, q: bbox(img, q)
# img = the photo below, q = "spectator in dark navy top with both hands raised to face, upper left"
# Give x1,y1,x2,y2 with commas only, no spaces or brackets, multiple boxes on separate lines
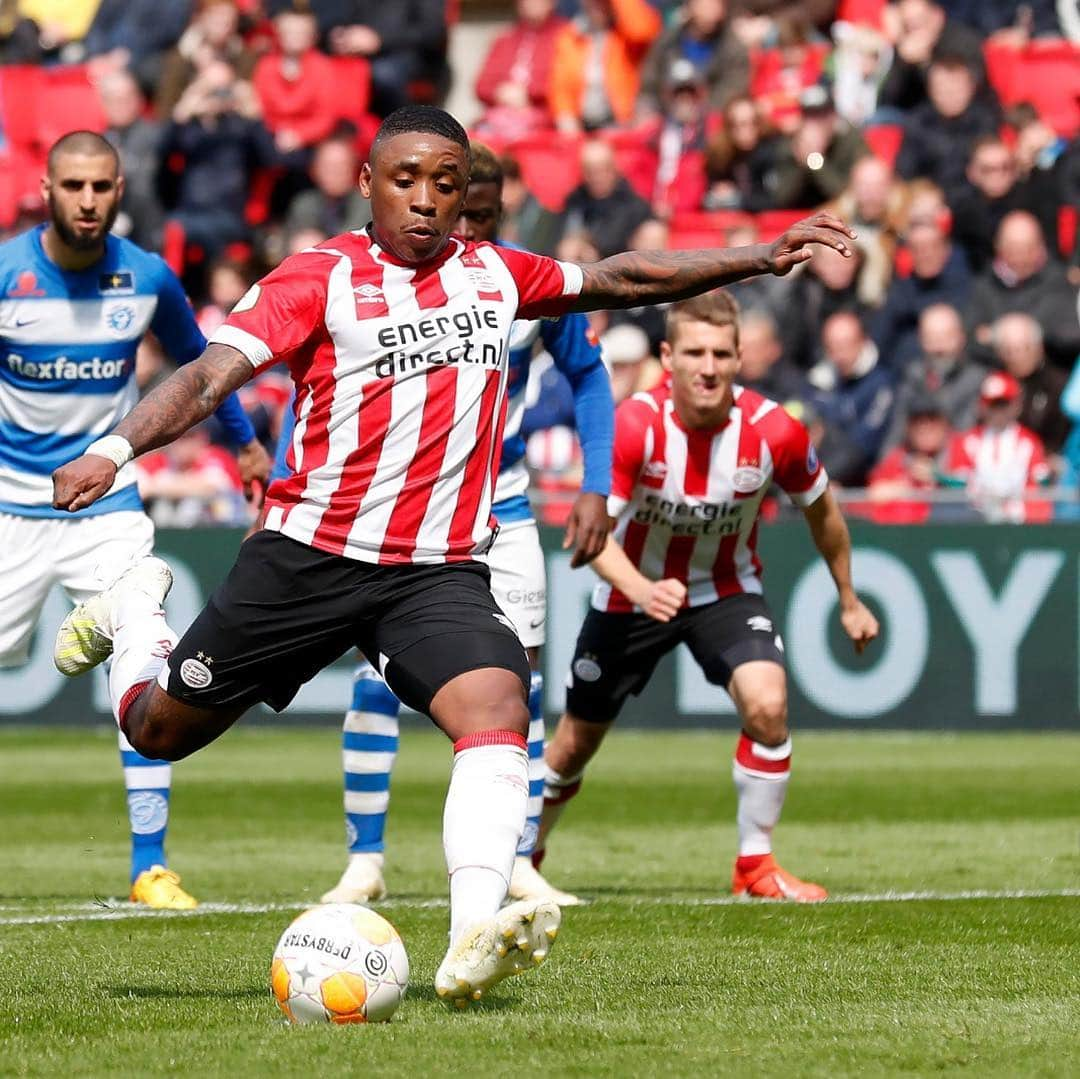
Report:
162,59,276,257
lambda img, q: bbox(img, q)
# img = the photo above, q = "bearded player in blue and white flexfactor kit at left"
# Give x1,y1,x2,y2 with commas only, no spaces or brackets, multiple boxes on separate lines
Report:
0,132,270,908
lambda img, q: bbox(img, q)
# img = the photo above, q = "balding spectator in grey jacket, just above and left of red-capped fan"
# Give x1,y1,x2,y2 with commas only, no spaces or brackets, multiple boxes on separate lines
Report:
885,304,986,447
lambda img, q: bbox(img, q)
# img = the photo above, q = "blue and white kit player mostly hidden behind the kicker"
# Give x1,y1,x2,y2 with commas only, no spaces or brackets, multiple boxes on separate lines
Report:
273,144,615,904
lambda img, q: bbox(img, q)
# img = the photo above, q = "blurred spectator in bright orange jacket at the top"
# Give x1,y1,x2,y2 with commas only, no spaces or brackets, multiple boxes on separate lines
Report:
551,0,660,133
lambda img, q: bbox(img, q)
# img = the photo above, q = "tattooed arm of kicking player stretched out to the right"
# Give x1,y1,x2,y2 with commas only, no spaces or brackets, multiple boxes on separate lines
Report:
572,213,855,311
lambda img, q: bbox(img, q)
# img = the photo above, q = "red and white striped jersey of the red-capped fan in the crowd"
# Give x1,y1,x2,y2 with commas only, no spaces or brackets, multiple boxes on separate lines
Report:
946,423,1050,522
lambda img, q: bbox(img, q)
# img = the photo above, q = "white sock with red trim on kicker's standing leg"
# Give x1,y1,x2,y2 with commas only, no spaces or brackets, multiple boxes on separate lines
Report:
443,730,529,946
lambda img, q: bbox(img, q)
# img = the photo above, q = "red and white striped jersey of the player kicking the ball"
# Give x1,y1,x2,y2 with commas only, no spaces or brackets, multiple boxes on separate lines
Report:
212,231,582,565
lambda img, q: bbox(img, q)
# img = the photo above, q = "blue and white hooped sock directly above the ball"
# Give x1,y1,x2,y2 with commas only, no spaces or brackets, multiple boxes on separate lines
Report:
341,663,401,854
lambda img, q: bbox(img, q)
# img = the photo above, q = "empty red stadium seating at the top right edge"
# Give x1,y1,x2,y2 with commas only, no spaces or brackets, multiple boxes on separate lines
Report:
984,39,1080,137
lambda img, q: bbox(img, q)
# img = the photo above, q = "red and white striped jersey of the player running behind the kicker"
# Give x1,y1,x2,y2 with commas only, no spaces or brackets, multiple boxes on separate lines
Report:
593,386,828,611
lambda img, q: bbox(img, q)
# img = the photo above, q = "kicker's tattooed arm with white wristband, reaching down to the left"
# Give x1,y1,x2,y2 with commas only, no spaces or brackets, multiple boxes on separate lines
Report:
53,343,255,512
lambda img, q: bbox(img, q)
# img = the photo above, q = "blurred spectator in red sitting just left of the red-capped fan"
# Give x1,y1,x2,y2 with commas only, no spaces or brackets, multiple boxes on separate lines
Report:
866,396,951,525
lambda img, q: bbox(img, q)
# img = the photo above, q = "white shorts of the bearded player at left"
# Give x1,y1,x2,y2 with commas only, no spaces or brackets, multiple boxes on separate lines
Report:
0,510,153,667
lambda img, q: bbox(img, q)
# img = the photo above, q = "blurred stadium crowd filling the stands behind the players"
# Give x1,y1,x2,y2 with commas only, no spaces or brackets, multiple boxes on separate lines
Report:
0,0,1080,524
